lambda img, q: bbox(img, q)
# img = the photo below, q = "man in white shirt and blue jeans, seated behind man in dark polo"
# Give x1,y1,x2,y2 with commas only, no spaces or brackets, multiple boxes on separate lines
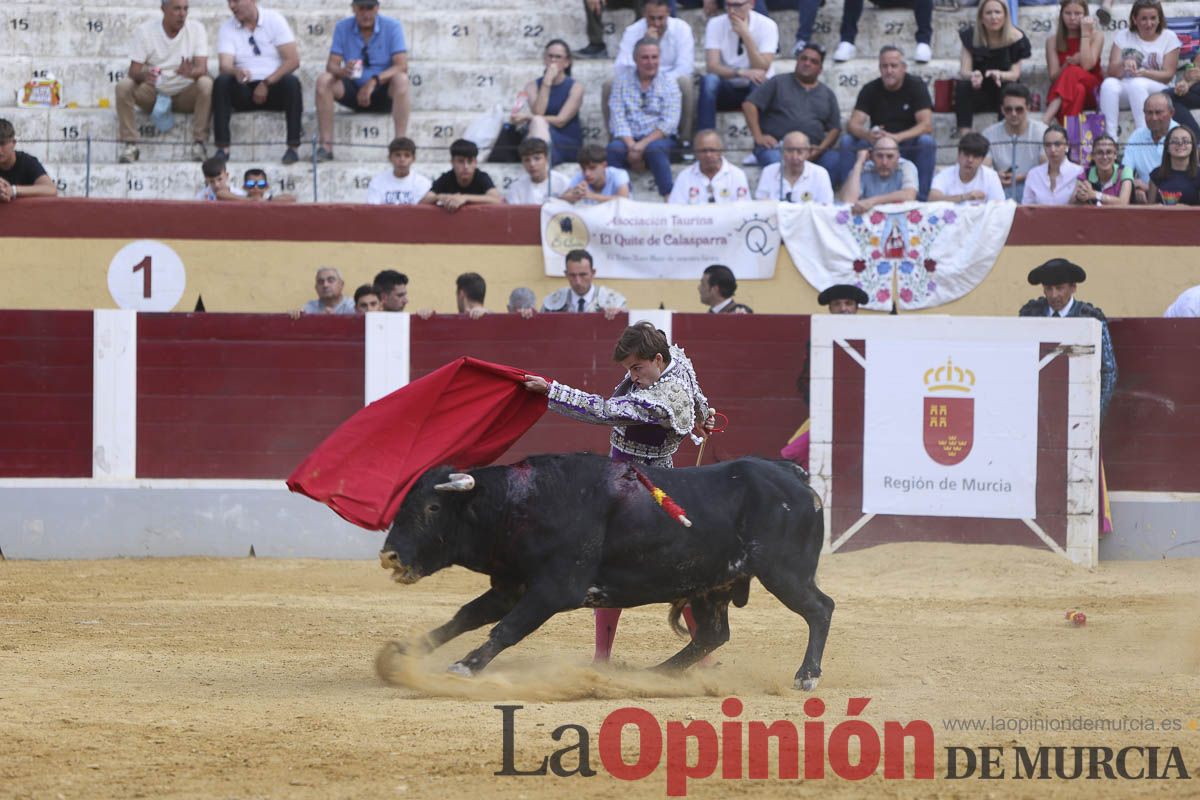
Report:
696,0,779,131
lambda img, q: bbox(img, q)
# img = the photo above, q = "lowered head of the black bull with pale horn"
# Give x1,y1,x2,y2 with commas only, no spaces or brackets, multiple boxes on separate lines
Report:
379,469,475,584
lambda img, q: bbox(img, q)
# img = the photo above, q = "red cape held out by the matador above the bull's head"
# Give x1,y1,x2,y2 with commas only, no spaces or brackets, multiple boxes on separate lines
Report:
288,357,546,530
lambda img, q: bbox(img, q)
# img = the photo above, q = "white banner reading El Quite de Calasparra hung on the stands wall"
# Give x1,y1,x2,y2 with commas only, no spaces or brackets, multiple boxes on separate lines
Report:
541,199,780,281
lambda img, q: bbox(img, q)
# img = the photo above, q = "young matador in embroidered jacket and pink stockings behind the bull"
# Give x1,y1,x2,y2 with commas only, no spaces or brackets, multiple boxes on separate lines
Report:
524,321,716,662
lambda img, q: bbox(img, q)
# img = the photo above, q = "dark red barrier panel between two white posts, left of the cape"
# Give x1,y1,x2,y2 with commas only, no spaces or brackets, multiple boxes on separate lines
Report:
137,314,364,477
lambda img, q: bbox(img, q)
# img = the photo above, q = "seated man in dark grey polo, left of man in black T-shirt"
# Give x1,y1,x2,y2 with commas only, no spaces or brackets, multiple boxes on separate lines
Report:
742,44,844,186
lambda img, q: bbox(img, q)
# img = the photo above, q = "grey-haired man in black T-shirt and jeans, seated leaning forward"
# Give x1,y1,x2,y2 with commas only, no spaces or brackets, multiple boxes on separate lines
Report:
841,44,937,200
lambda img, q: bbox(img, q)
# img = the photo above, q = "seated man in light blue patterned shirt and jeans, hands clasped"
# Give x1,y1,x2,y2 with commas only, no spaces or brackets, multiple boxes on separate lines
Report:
607,38,679,198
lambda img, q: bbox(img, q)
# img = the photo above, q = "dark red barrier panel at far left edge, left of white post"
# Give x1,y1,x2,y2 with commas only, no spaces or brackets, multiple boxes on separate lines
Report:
0,311,92,477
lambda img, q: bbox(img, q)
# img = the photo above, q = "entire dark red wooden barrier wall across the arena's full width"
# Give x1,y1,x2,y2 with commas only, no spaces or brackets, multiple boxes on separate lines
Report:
0,311,1200,491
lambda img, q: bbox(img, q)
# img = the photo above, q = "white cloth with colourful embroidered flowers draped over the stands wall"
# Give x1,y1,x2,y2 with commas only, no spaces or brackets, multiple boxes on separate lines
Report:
779,201,1016,311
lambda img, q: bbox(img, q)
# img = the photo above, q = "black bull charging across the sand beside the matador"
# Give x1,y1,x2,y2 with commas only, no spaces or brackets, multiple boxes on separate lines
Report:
379,453,834,690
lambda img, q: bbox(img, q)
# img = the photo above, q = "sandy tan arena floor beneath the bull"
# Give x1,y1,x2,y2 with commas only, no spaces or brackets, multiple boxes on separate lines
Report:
0,545,1200,800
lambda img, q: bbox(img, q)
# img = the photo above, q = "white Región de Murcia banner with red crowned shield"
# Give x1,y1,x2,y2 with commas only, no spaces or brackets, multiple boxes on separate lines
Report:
863,338,1038,519
